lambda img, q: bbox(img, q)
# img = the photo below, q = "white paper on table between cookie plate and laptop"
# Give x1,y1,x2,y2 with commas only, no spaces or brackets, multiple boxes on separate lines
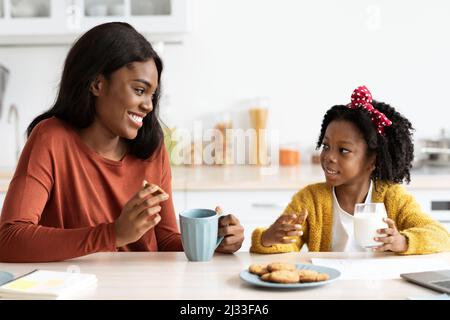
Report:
311,257,450,280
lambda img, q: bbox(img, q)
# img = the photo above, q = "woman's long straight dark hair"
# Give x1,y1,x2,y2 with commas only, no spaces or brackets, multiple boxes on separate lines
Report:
27,22,164,159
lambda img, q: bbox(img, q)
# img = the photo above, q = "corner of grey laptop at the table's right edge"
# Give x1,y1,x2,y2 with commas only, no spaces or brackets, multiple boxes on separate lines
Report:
400,270,450,294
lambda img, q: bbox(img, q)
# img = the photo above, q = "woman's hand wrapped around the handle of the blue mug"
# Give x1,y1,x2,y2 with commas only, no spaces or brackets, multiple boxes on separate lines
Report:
216,207,244,253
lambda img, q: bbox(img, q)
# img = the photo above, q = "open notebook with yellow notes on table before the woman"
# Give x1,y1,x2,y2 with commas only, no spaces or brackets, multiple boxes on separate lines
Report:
0,270,97,300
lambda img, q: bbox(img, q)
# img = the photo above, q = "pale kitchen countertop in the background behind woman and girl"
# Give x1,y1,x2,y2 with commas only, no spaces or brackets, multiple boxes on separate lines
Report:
0,164,450,192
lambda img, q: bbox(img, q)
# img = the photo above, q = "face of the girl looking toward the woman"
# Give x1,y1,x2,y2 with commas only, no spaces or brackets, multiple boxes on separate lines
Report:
320,120,375,187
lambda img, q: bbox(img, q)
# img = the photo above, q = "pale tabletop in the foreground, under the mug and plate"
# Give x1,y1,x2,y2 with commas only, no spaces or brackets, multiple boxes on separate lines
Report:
0,252,450,301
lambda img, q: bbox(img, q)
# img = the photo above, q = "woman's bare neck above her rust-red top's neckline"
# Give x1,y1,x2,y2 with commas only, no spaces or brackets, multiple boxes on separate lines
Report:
78,120,128,161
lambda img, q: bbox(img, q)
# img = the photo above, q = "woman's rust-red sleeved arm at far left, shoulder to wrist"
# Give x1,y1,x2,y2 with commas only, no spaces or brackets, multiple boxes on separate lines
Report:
0,122,116,262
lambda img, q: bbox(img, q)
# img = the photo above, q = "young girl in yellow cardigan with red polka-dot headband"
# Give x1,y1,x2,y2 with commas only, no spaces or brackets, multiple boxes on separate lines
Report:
250,86,450,254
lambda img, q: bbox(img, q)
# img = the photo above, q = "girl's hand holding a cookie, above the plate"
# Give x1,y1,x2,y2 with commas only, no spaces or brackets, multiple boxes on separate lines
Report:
261,209,308,247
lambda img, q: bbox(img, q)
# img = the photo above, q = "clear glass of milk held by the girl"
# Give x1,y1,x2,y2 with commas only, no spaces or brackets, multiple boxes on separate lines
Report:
353,202,388,248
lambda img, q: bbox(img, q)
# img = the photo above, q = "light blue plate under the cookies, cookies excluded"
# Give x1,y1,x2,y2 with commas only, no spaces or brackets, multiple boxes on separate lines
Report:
239,263,341,289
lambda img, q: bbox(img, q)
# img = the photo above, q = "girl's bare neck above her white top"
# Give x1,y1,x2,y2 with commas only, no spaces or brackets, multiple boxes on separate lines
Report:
334,178,370,214
